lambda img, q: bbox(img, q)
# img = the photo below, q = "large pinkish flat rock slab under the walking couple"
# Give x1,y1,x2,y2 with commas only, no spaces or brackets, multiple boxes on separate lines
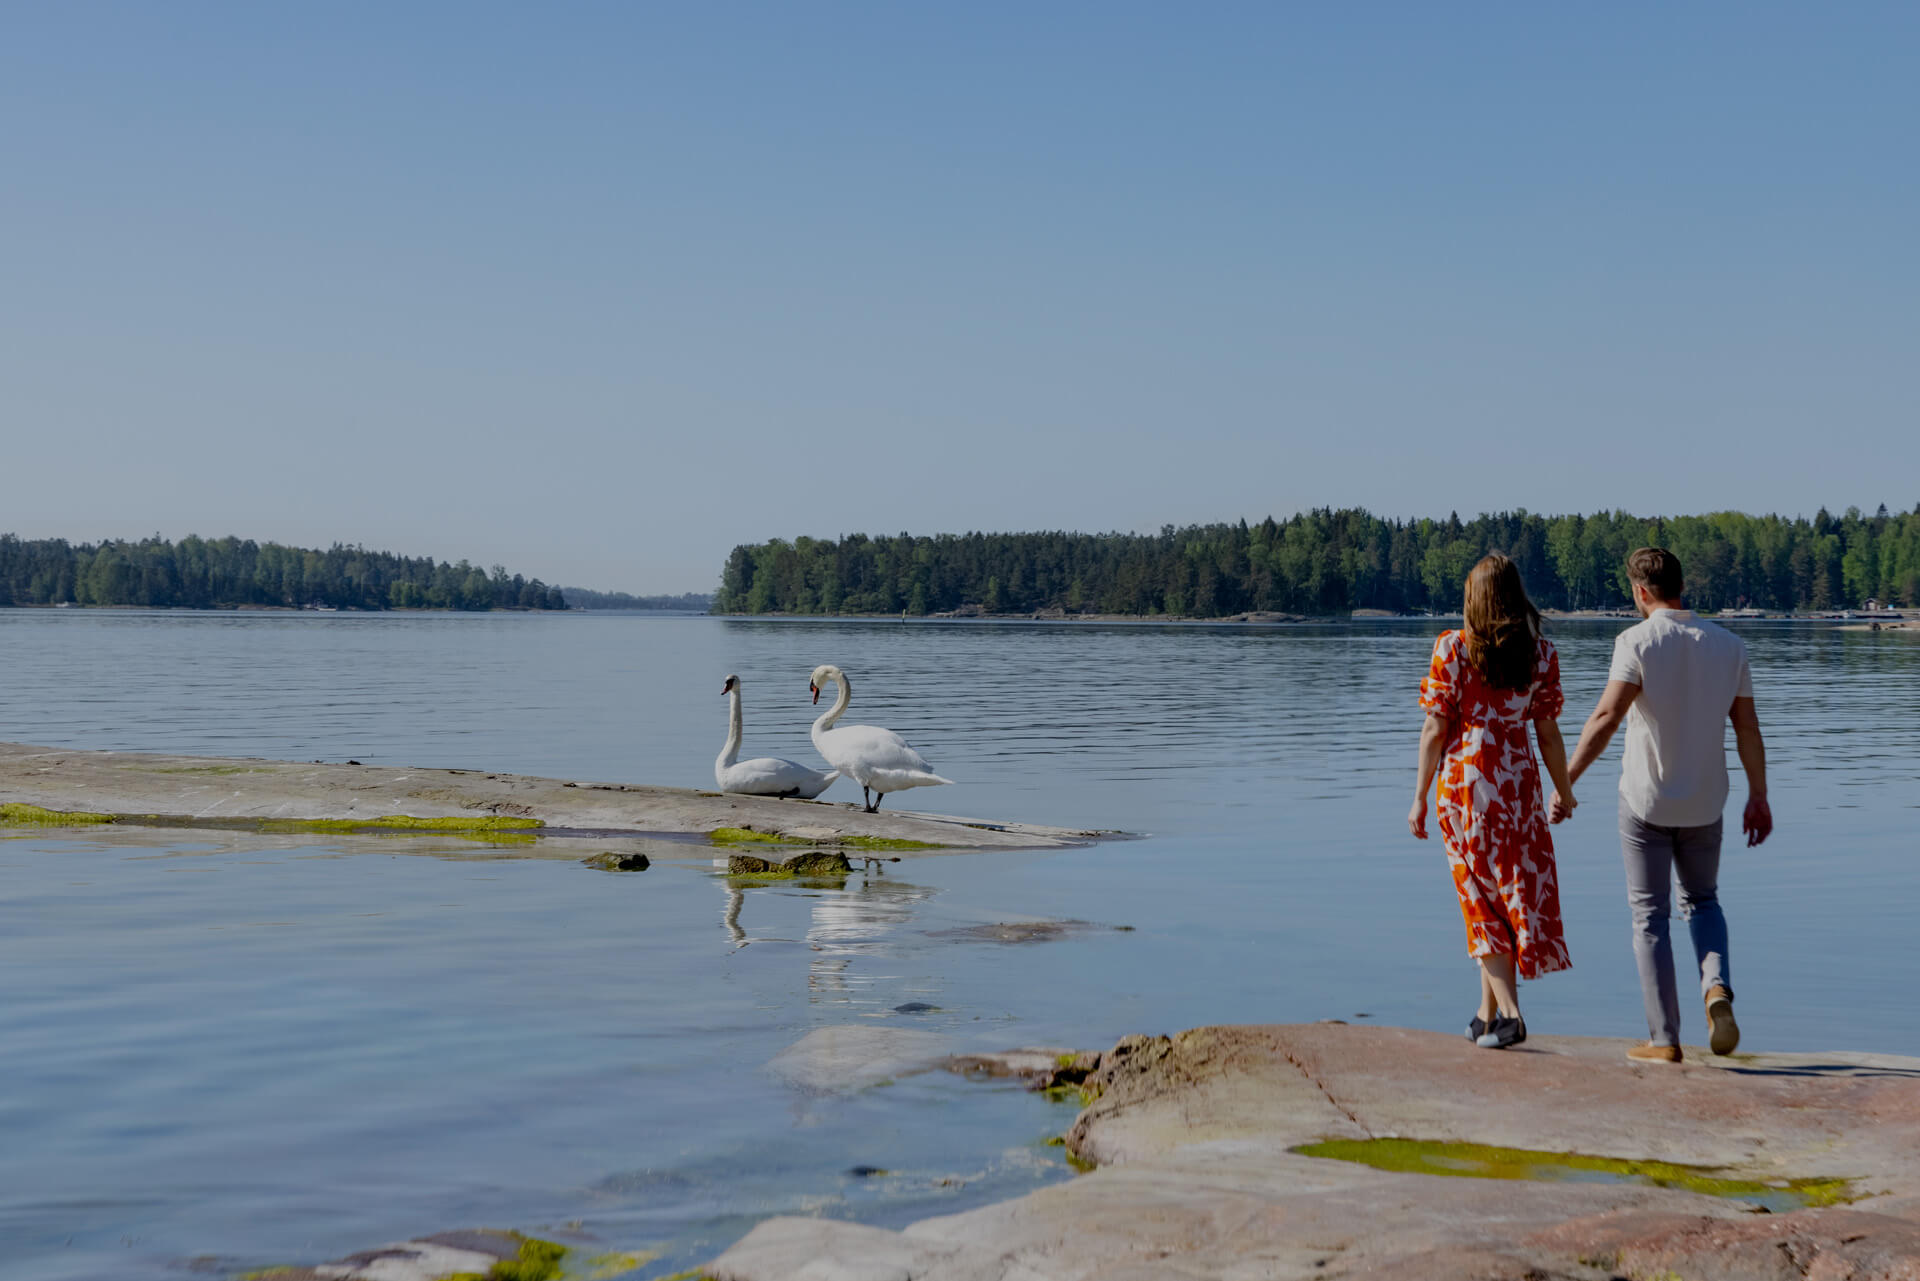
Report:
708,1024,1920,1281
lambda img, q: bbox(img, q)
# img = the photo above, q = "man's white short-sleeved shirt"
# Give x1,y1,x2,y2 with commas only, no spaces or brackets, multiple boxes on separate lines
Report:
1607,609,1753,828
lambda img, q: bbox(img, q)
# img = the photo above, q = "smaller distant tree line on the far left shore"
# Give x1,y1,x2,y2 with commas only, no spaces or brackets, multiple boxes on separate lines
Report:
0,534,566,609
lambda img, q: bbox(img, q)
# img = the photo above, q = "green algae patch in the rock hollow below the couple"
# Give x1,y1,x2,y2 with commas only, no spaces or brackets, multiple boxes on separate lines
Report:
1294,1139,1853,1214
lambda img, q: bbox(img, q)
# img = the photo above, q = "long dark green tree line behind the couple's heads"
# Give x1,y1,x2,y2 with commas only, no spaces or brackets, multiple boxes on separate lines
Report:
714,505,1920,618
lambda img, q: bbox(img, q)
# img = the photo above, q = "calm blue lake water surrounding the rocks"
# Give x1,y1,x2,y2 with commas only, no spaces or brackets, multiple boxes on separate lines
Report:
0,611,1920,1279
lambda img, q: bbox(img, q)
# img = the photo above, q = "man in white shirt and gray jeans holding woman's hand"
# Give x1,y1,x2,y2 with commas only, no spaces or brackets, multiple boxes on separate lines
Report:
1553,547,1774,1064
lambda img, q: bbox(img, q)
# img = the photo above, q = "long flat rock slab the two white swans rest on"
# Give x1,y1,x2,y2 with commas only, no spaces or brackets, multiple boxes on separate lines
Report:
0,743,1112,853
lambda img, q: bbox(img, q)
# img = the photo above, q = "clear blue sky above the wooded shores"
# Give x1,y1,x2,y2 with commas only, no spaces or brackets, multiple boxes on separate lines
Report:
0,0,1920,592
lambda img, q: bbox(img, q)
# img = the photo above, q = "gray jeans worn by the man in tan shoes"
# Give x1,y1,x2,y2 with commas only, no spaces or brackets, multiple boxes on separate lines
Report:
1620,801,1734,1045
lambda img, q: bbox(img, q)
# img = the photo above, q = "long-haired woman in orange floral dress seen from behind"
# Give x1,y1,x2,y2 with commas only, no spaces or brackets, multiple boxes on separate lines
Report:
1407,553,1574,1051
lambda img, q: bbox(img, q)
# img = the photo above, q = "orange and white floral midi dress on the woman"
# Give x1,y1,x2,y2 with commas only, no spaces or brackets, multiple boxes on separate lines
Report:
1421,632,1572,979
